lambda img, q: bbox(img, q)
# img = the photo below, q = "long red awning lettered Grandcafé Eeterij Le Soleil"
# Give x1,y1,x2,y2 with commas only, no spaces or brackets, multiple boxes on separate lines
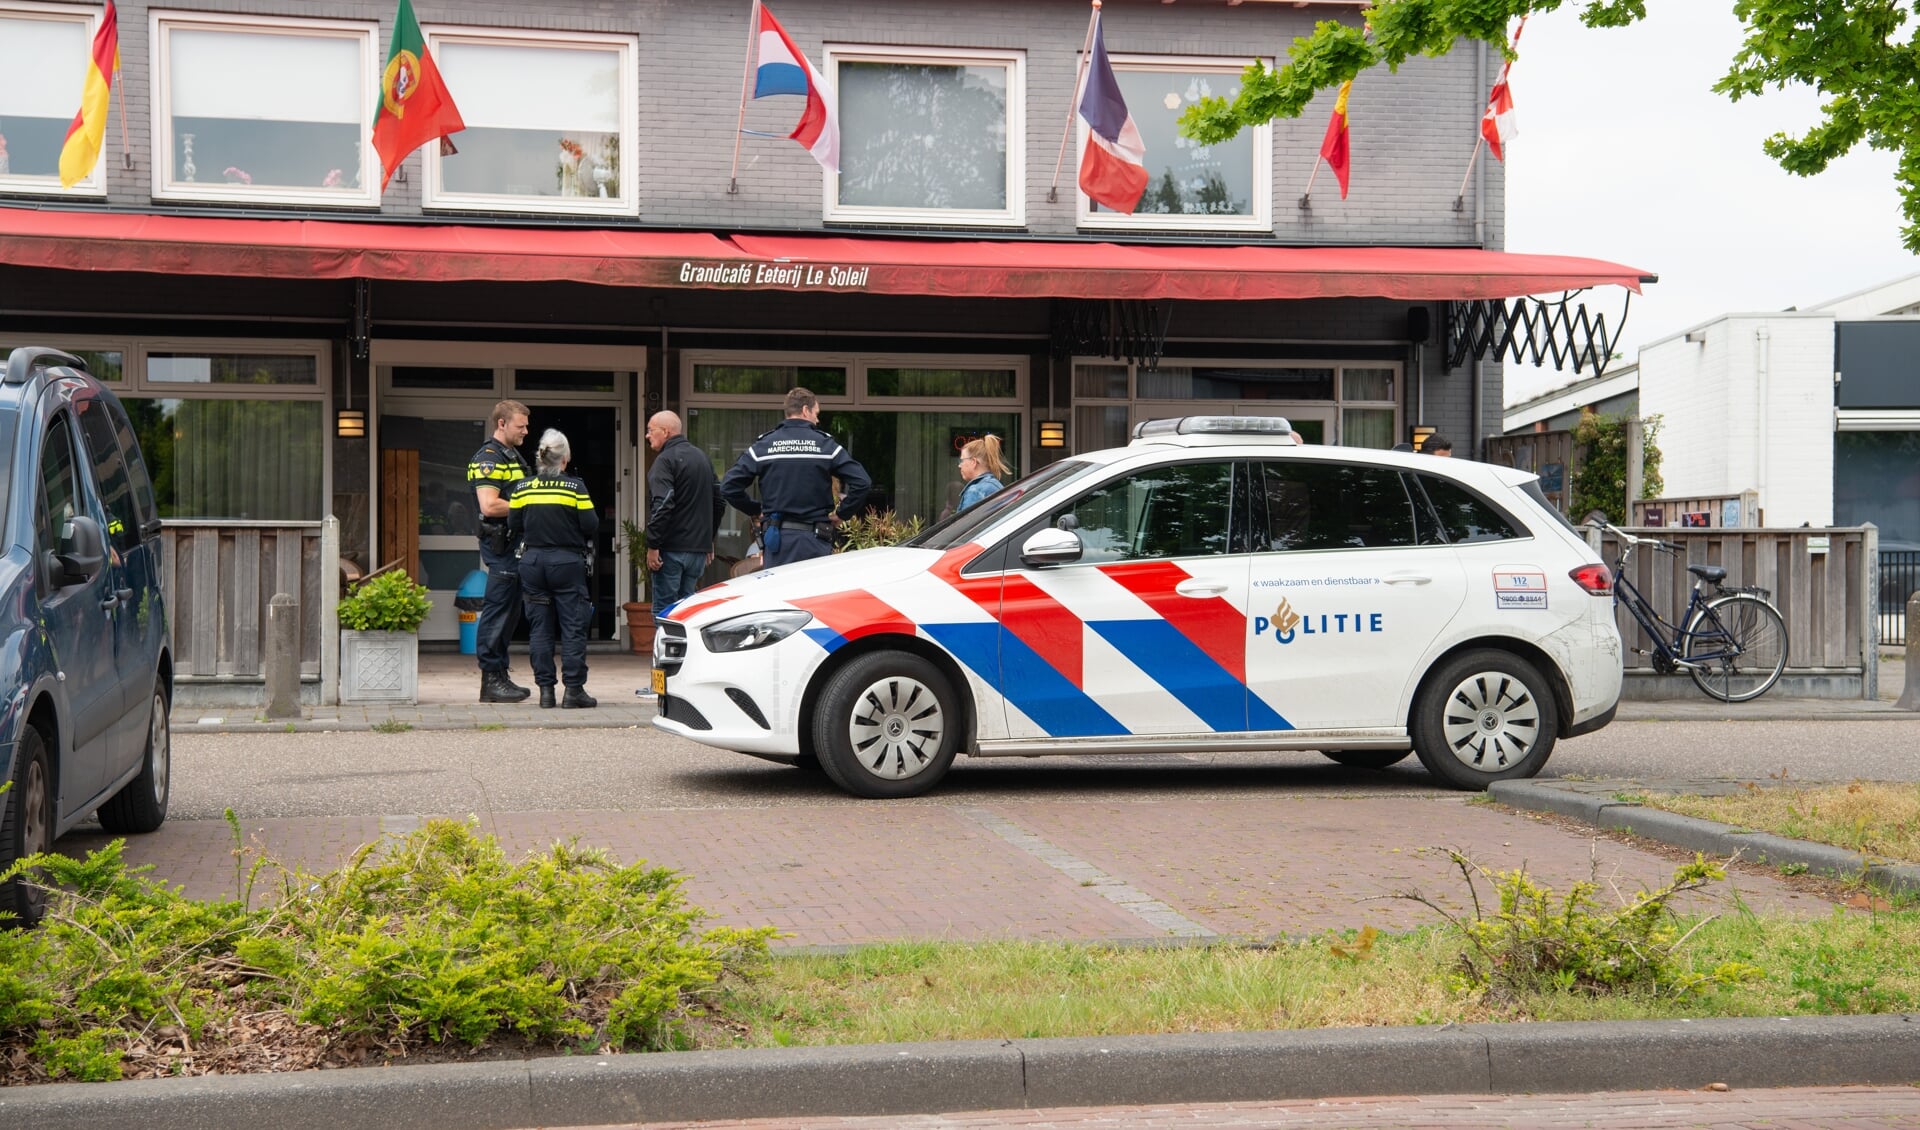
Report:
0,207,1653,301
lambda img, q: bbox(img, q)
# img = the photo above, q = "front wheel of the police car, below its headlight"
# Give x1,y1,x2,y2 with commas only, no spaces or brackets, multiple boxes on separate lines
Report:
814,650,960,798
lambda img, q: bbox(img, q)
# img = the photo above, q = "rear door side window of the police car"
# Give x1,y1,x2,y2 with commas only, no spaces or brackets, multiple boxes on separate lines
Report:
1256,460,1415,551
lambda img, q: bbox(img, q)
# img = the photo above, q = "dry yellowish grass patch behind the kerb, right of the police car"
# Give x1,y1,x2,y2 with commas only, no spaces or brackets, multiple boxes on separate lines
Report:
1638,781,1920,863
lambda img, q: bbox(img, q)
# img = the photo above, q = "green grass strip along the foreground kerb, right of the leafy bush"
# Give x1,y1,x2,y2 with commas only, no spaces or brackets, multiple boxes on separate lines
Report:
697,909,1920,1048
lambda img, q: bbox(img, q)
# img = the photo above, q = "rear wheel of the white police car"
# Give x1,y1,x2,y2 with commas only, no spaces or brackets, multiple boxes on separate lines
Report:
1411,650,1557,789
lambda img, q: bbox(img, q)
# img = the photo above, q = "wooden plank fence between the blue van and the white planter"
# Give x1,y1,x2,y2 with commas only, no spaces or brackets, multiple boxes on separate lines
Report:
161,520,340,702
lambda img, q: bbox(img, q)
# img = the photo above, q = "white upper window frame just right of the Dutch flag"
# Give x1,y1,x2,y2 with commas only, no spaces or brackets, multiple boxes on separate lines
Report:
820,44,1027,228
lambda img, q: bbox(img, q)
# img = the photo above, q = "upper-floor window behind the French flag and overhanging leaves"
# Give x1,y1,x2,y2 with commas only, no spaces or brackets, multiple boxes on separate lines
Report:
1075,56,1273,230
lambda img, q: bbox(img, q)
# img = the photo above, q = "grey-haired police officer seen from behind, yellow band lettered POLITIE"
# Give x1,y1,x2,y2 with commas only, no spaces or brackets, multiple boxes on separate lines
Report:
507,428,599,710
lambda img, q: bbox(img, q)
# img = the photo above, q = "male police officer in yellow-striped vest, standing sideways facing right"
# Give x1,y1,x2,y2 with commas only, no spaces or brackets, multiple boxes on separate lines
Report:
467,401,530,702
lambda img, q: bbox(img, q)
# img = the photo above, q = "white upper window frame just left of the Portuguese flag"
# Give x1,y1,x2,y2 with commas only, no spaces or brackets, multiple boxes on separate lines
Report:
148,8,380,209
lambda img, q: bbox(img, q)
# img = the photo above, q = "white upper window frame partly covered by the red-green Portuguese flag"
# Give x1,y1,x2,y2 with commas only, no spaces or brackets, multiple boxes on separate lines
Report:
420,23,639,217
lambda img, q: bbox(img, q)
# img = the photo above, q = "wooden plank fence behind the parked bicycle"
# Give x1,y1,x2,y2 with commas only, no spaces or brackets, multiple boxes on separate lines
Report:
1588,526,1880,698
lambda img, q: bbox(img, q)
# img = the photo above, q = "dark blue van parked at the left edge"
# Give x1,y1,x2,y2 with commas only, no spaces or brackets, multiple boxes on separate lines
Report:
0,349,173,925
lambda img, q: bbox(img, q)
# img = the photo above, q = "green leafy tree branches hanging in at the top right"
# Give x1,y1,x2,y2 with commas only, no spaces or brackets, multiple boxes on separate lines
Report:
1179,0,1920,251
